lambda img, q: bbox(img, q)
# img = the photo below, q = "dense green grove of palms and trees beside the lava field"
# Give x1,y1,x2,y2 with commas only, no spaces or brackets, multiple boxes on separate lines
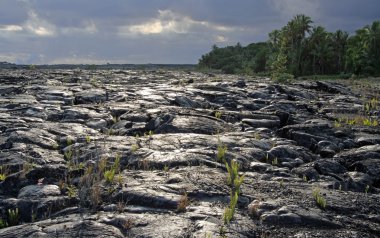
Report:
199,14,380,77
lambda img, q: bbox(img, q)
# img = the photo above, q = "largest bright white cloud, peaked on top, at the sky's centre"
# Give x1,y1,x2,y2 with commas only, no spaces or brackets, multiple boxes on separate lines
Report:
119,10,241,36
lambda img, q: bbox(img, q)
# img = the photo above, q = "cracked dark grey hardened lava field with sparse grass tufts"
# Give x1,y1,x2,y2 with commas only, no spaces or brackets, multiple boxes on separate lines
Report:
0,70,380,238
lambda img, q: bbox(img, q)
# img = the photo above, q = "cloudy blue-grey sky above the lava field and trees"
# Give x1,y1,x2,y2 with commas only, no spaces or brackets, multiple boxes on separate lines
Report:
0,0,380,64
